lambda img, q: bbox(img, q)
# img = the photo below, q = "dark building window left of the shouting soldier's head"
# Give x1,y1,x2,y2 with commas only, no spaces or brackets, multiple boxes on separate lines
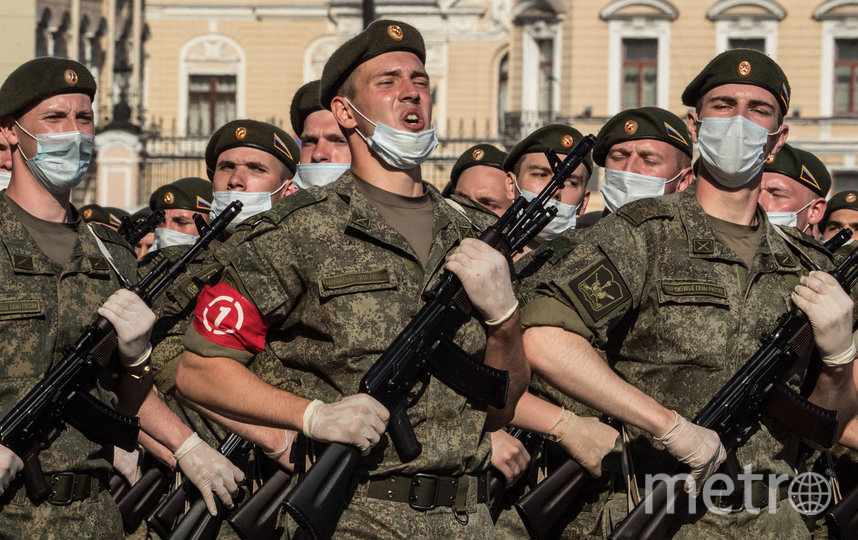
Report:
187,75,236,136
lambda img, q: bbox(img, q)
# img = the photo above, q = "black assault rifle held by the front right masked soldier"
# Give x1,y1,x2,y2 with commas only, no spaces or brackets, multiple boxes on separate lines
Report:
609,243,858,539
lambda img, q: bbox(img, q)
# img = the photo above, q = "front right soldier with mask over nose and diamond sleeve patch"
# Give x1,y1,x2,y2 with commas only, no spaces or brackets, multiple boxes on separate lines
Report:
523,49,855,537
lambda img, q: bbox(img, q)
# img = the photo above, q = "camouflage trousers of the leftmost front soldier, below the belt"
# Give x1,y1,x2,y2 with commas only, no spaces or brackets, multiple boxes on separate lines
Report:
0,478,123,540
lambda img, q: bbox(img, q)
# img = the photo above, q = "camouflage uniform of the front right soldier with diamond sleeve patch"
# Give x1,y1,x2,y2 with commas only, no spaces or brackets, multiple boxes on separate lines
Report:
523,191,831,538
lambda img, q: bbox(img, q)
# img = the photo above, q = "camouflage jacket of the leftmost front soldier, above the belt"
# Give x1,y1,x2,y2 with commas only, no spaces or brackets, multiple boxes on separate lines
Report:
0,195,136,472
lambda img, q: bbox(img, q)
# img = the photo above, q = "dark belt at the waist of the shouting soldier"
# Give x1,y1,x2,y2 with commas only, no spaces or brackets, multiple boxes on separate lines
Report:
366,471,489,511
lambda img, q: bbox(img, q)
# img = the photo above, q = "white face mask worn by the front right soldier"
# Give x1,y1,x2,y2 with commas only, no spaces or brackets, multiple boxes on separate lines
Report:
697,116,780,188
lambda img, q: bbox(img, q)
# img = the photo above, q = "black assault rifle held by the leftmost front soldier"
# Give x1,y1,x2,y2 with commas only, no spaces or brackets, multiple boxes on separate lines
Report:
0,201,241,501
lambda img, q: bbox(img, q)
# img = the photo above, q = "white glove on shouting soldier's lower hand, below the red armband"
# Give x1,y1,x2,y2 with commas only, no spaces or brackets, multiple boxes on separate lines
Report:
303,394,390,456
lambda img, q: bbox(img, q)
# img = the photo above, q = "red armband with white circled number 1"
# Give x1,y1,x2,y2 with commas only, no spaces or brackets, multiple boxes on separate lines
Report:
194,282,268,353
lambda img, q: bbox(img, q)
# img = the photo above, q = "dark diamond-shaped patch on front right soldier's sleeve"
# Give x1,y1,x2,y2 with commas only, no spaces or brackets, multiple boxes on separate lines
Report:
564,258,631,322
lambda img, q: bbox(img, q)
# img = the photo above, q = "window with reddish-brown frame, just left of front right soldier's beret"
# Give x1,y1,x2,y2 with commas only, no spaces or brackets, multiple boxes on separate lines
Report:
622,39,658,109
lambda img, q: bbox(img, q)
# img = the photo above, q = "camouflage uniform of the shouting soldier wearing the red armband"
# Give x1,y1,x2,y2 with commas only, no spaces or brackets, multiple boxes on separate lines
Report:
185,172,491,538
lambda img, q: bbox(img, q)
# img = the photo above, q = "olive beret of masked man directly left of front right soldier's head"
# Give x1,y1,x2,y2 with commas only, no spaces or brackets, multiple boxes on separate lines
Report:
593,107,692,167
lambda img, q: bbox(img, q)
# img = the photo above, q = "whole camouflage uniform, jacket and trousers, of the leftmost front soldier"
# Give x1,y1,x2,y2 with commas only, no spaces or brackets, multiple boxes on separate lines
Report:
0,194,136,538
